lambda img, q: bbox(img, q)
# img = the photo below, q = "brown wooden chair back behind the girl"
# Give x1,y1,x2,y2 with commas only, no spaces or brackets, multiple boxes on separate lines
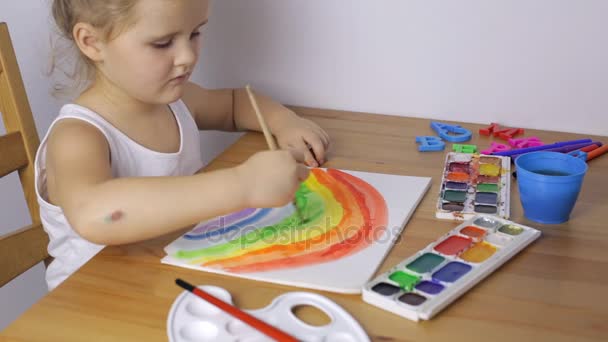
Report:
0,23,49,287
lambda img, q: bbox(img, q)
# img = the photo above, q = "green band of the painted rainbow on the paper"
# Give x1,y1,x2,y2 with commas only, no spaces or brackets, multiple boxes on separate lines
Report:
175,183,332,259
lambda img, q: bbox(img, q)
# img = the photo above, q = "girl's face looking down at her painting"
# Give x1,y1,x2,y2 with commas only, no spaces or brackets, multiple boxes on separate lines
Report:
98,0,209,104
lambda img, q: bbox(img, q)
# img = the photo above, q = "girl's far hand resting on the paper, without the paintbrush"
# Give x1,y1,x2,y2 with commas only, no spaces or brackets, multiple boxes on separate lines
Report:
272,113,330,167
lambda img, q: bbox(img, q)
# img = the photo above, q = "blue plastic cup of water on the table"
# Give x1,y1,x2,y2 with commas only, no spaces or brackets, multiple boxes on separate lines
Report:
515,151,587,224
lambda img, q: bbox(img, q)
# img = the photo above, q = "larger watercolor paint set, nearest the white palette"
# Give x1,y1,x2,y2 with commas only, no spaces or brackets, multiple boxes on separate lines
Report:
363,215,541,321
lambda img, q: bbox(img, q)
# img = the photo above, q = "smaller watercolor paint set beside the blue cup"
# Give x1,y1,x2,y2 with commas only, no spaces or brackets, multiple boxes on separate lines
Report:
435,152,511,220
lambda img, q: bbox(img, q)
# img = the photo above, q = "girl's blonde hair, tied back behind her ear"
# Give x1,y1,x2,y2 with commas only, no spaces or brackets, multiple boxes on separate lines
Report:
49,0,139,95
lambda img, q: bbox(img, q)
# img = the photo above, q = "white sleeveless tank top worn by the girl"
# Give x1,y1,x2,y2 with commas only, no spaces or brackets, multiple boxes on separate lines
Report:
35,100,203,290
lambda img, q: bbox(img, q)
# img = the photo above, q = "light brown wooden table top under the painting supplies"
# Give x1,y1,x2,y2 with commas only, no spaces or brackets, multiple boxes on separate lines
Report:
0,108,608,341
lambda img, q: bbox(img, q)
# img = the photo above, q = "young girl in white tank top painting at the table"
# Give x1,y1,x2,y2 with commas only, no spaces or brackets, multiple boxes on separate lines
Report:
36,0,329,289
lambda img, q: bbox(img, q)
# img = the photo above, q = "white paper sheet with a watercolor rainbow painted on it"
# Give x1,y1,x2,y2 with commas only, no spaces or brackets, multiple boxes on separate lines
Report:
163,168,428,292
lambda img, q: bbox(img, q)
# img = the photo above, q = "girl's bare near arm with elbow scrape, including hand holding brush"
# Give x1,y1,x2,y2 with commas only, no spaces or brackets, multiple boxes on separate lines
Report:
47,119,307,245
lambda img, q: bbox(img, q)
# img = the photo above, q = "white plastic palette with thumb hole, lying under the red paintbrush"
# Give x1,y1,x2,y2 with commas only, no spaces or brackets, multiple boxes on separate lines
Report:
167,286,369,342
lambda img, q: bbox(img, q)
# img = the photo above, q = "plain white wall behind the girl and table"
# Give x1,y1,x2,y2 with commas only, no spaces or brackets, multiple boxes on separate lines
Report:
0,0,608,330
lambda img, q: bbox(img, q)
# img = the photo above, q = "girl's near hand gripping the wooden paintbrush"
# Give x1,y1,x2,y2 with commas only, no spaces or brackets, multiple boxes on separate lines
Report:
236,150,310,208
